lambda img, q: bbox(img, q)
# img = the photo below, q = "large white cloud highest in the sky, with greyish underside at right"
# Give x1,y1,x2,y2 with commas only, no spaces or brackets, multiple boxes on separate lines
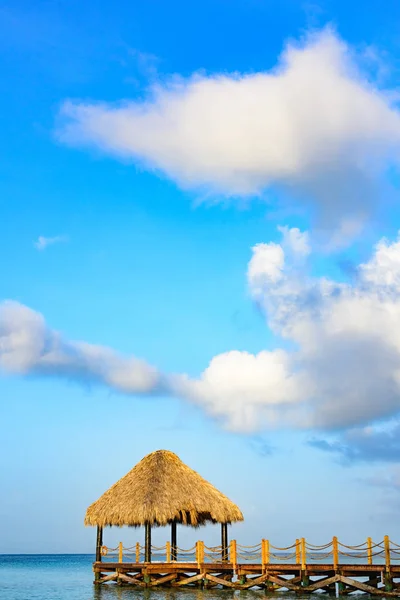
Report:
58,30,400,235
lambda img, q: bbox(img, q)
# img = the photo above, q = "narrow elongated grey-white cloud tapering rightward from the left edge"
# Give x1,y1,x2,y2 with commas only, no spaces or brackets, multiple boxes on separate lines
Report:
0,302,166,394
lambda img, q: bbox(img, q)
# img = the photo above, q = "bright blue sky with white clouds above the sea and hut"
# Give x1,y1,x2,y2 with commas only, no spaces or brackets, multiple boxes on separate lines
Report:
0,0,400,552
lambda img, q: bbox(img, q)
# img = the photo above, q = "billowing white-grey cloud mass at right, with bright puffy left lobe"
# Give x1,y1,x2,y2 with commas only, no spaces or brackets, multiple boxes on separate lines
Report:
182,229,400,432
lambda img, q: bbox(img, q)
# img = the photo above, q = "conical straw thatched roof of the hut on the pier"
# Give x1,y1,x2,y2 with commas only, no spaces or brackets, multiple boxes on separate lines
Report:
85,450,243,527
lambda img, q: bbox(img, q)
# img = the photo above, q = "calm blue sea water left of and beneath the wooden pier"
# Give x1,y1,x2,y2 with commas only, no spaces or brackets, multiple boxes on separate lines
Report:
0,554,316,600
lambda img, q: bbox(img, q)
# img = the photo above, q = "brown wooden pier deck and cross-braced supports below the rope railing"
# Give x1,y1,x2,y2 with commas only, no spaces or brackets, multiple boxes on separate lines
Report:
93,562,400,597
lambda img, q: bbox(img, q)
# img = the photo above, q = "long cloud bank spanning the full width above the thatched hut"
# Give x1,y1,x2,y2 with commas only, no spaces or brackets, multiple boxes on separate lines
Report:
5,228,400,440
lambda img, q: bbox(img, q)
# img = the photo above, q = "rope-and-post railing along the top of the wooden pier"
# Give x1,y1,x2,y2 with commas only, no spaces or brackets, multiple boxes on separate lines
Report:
101,535,400,569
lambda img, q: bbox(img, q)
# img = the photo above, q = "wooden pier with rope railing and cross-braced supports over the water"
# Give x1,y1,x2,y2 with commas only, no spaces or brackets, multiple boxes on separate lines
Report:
93,536,400,597
